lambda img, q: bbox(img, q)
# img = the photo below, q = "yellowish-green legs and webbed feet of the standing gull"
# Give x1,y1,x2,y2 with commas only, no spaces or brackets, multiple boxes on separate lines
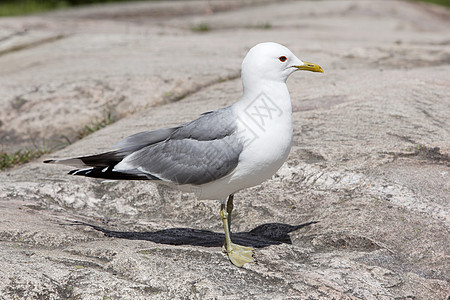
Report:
220,195,255,267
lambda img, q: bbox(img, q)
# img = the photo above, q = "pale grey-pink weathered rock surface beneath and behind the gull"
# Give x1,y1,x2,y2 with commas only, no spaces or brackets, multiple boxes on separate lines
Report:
0,1,450,299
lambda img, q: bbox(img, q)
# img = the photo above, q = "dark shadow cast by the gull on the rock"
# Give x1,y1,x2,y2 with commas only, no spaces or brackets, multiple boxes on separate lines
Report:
69,221,318,248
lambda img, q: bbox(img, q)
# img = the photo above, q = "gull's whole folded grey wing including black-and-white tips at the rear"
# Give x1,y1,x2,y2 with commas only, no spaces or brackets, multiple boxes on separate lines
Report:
45,108,243,185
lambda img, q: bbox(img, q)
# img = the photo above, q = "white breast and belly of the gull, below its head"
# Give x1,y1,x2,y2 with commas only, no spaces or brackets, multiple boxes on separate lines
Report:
196,88,292,199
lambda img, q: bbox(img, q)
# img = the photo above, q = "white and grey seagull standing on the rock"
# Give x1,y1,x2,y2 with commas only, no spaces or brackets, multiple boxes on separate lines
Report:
44,42,323,267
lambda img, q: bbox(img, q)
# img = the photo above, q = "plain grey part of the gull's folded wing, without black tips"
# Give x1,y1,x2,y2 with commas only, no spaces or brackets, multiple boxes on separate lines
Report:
114,108,243,185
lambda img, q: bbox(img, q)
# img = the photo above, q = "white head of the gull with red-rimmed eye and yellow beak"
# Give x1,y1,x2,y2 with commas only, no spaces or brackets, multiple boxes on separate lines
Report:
241,42,323,86
